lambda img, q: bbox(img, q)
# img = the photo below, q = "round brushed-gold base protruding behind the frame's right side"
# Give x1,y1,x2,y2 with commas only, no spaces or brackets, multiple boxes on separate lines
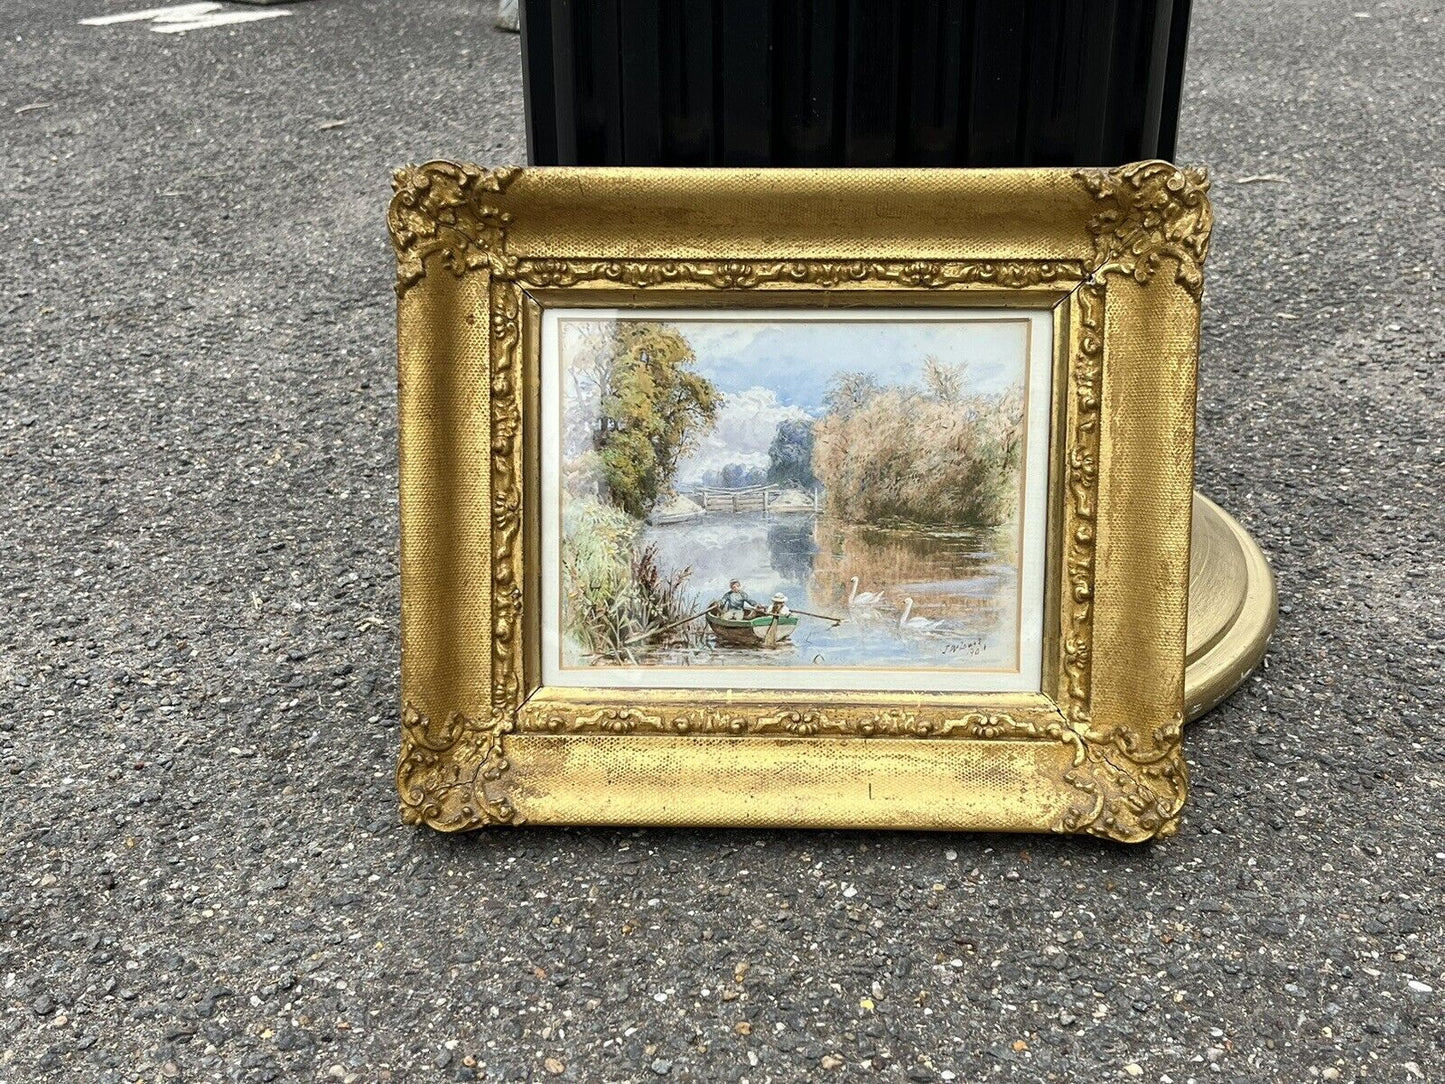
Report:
1183,491,1279,720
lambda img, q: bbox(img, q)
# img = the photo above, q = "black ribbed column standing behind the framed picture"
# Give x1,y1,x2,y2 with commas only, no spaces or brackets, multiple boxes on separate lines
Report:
522,0,1189,166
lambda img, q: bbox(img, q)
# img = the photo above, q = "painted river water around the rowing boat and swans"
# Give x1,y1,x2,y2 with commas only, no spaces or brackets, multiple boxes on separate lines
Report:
637,512,1019,671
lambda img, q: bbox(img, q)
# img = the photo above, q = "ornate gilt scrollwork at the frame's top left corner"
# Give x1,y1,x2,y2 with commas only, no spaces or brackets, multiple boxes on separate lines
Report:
386,162,522,296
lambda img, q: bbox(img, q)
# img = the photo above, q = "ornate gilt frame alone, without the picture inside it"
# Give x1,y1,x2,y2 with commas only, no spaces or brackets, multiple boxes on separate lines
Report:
389,162,1212,841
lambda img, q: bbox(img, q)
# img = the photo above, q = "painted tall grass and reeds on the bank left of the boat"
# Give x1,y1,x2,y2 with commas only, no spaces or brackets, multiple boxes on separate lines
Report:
562,497,699,659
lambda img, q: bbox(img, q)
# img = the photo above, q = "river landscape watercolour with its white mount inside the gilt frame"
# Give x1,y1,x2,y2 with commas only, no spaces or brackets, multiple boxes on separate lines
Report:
540,309,1053,692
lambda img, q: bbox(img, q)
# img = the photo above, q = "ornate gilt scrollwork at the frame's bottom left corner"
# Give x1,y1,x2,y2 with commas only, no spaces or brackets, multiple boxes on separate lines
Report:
396,704,522,831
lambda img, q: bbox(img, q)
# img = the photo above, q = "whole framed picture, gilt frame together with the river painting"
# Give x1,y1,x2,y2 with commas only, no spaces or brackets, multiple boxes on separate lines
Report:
389,162,1211,843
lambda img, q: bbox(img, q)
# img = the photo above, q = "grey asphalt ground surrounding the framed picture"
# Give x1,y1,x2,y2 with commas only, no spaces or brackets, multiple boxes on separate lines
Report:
0,0,1445,1084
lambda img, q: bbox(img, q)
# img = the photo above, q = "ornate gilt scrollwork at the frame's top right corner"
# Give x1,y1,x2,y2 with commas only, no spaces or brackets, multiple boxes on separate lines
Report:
1074,162,1214,302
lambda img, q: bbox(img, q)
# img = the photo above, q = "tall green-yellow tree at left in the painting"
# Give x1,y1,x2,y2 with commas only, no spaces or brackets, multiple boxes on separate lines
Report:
594,321,723,519
